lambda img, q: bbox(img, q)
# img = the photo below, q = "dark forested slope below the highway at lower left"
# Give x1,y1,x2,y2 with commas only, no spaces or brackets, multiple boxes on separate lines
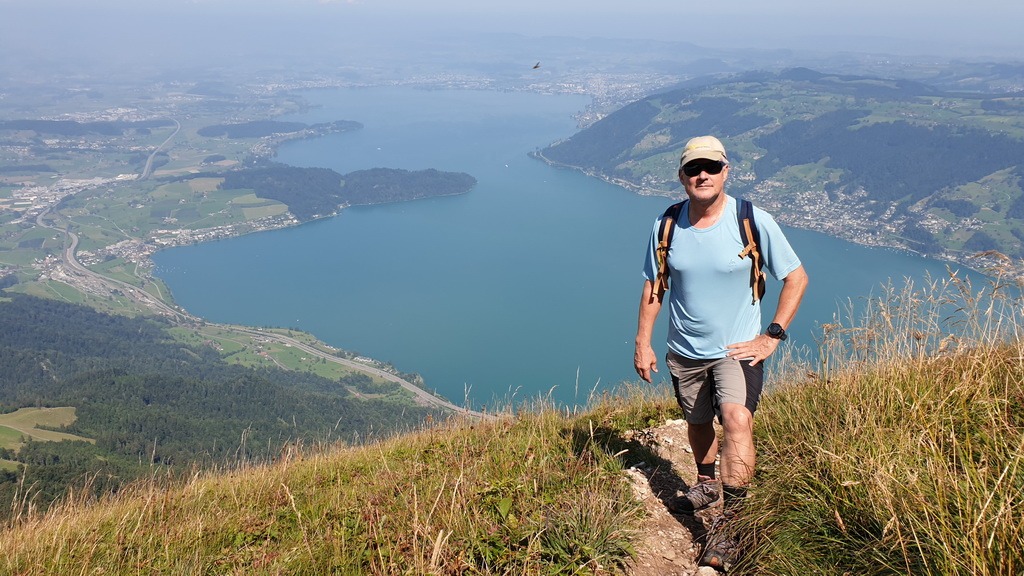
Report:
0,294,442,517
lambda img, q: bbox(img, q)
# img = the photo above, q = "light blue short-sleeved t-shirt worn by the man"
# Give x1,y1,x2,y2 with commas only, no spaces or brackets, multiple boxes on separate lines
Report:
643,196,800,360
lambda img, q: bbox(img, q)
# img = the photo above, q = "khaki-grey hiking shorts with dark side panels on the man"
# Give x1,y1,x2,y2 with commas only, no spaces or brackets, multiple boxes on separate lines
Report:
665,352,764,424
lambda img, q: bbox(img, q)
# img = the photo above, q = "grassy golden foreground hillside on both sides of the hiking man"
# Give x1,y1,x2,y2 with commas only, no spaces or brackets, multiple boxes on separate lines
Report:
0,277,1024,576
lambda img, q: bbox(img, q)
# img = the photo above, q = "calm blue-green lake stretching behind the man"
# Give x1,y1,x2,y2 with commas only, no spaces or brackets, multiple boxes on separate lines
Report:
155,87,983,407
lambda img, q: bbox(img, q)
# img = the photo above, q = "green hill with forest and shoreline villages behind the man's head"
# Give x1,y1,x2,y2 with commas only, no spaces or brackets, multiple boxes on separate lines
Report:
539,69,1024,266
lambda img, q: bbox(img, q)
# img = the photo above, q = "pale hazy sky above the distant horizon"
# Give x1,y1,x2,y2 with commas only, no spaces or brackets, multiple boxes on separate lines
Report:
0,0,1024,69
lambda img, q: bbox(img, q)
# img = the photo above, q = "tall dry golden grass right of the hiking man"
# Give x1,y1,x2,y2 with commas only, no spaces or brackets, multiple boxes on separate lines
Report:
739,266,1024,575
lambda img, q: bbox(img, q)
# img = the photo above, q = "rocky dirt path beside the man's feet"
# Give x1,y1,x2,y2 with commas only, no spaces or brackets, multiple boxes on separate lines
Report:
629,420,719,576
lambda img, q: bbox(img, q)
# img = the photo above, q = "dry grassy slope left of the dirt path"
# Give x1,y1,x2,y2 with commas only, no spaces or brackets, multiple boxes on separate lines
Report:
0,389,679,575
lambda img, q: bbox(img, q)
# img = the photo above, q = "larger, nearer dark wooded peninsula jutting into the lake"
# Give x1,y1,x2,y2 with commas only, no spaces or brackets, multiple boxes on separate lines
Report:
220,163,476,221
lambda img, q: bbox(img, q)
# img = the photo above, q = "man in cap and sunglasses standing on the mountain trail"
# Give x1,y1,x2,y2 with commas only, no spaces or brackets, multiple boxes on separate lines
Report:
633,136,807,568
